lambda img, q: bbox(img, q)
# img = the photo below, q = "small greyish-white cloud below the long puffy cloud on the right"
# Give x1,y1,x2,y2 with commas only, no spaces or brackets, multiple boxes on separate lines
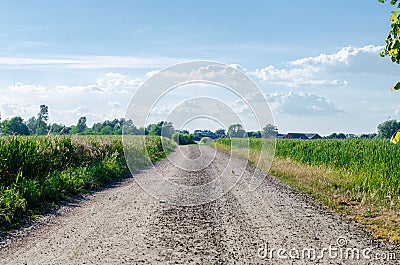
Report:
266,92,345,115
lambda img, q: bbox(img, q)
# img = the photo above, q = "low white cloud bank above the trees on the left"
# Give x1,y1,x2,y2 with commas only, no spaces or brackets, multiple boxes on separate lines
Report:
0,73,142,125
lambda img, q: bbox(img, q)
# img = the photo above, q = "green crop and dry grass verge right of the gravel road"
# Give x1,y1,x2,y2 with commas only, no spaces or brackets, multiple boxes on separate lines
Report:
216,138,400,244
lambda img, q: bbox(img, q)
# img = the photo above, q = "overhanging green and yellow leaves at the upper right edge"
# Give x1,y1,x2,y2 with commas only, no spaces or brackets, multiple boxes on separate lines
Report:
378,0,400,90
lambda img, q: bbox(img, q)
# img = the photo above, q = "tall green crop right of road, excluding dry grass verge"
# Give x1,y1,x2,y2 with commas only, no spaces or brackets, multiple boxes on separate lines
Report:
217,138,400,207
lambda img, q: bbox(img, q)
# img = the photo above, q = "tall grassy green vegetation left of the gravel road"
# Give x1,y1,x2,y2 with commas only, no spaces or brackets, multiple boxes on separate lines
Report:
0,136,175,231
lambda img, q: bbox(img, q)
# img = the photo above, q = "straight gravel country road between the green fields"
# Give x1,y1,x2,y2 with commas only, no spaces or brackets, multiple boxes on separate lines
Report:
0,145,400,264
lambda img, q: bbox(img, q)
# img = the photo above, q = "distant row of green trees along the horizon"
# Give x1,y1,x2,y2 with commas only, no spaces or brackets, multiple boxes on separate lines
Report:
0,105,400,139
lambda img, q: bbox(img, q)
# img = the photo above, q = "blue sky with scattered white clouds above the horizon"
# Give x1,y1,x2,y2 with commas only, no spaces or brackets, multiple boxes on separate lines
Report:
0,0,400,135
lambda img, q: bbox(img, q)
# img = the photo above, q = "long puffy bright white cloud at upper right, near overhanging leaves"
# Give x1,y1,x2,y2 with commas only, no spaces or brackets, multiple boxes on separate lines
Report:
247,45,388,87
